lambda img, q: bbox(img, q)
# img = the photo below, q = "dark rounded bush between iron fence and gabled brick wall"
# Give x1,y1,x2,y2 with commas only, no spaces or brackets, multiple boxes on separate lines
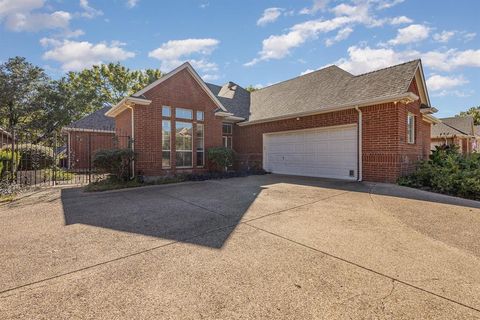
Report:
93,149,134,181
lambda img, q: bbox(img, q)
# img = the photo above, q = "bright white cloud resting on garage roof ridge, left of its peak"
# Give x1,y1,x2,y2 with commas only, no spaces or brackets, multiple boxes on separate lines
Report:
336,46,420,74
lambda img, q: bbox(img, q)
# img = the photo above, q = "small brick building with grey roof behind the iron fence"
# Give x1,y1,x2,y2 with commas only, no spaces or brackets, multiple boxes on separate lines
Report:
62,107,115,170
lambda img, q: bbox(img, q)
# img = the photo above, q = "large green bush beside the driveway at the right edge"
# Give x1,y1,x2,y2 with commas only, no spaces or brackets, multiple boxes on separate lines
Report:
398,146,480,200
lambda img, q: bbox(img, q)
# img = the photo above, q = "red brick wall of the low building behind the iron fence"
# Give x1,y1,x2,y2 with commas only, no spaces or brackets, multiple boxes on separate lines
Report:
67,131,115,170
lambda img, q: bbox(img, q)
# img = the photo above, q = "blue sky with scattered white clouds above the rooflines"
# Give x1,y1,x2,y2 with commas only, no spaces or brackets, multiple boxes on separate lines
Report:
0,0,480,117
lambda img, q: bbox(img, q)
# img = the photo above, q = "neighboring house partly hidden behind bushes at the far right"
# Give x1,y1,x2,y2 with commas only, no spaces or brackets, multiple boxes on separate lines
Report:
432,116,480,154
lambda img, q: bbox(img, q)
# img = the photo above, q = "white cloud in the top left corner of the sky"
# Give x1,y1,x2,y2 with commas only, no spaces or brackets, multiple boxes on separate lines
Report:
0,0,72,31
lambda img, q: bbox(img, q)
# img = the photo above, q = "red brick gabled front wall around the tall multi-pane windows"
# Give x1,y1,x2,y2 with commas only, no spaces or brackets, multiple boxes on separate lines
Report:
116,70,226,176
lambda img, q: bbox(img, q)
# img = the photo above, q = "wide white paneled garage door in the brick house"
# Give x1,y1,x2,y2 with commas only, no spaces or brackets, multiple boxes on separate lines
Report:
263,125,358,180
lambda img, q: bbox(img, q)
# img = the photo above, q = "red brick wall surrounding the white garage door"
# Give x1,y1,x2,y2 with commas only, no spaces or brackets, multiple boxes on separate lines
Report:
233,92,430,182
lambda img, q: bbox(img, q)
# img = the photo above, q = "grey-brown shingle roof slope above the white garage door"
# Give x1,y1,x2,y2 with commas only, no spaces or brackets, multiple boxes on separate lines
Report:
249,60,420,121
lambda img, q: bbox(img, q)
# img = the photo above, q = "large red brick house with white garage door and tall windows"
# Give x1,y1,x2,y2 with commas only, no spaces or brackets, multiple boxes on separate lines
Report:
106,60,437,182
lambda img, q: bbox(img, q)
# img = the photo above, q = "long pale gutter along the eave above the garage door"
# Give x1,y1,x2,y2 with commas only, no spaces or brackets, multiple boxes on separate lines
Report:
238,92,419,126
